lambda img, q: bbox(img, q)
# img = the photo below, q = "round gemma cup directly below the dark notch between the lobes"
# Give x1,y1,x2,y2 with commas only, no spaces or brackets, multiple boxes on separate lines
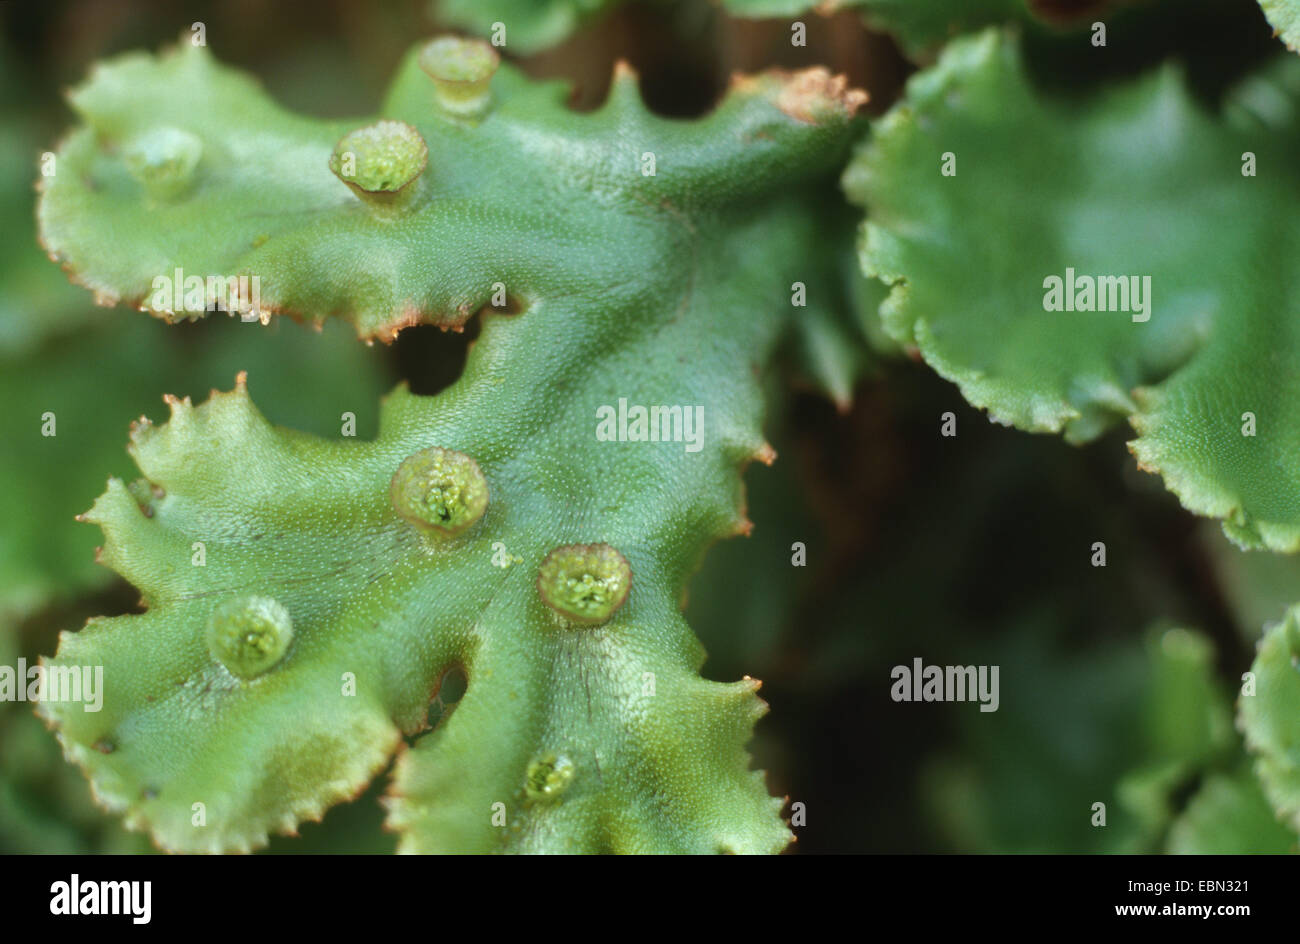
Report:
389,446,488,537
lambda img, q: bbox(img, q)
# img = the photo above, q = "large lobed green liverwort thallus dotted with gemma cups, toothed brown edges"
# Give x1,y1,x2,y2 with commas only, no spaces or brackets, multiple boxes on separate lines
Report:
32,27,858,852
